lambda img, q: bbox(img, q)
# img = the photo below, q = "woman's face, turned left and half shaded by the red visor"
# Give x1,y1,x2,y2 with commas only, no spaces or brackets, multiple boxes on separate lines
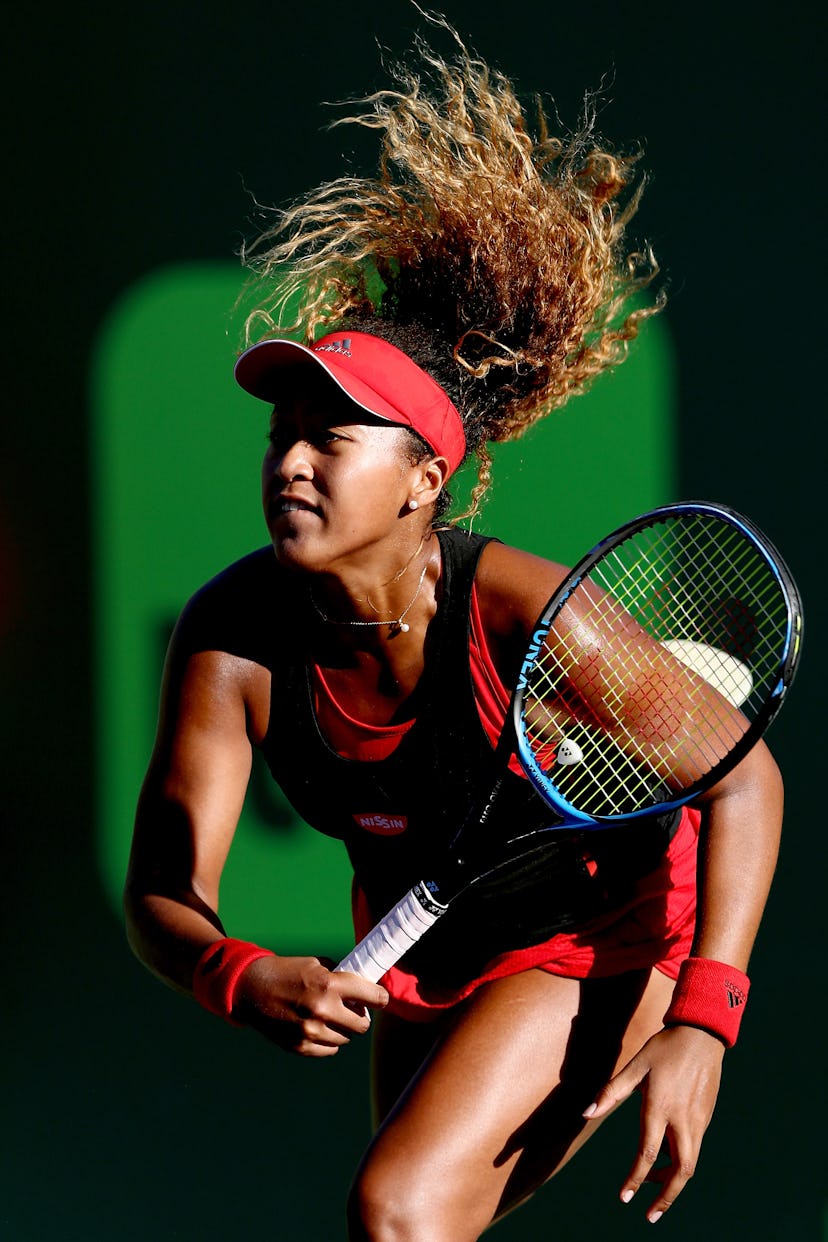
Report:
262,370,424,571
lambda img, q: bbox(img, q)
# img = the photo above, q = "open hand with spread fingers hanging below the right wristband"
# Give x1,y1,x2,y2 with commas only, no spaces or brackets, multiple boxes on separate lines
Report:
583,1026,725,1223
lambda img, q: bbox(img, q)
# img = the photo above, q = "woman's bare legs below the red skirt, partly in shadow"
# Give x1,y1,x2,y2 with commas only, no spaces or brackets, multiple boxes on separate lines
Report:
349,970,672,1242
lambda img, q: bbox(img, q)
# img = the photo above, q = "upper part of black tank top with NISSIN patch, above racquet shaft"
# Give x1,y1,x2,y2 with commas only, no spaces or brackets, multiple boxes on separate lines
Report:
262,530,539,899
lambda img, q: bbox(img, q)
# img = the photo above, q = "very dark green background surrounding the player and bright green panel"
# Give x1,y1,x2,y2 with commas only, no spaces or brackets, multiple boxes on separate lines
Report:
0,0,826,1242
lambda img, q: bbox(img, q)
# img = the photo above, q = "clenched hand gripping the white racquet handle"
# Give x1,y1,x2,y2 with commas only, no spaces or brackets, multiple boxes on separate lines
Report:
233,956,389,1057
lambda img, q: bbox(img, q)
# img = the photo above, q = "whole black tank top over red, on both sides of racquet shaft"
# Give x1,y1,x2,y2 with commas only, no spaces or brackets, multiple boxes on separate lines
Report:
256,529,678,986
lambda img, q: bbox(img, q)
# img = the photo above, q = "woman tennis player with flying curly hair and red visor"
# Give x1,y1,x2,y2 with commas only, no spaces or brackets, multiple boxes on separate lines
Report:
127,16,782,1242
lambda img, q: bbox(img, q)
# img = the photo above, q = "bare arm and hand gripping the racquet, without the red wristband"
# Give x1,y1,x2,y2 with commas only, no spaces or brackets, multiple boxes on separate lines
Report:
124,630,386,1056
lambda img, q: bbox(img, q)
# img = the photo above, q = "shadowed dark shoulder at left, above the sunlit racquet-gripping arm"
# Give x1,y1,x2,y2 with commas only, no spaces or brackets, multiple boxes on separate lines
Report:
174,545,293,664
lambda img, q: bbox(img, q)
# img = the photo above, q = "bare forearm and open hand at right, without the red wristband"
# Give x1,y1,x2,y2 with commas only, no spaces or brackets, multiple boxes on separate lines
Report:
586,741,782,1221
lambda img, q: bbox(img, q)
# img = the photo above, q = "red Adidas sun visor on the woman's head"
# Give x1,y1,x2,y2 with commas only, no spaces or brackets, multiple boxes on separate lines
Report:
236,332,466,471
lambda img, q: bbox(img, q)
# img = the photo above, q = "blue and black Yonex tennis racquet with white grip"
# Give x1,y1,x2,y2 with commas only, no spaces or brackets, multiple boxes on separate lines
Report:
336,503,802,982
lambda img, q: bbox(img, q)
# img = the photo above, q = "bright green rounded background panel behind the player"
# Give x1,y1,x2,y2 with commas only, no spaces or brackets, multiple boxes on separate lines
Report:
92,263,675,953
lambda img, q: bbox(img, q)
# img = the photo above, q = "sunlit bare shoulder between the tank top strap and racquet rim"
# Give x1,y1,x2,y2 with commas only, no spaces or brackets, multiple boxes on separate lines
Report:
475,540,569,643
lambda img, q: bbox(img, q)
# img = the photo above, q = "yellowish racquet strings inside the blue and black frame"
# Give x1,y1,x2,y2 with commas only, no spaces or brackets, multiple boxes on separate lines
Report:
521,513,790,817
